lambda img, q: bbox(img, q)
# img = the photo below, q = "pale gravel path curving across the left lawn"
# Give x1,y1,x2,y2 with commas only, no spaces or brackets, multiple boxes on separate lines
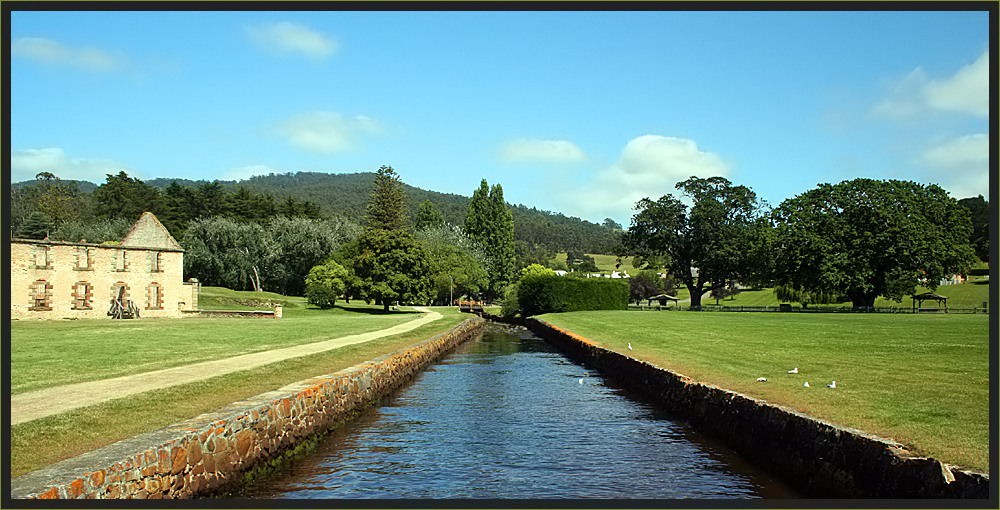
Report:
10,307,441,425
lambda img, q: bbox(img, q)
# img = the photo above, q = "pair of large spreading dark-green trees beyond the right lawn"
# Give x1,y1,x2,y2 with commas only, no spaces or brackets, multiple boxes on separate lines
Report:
620,177,989,308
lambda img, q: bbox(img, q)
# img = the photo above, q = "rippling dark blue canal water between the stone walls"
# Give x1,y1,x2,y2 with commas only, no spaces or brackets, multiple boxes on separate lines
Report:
234,325,798,499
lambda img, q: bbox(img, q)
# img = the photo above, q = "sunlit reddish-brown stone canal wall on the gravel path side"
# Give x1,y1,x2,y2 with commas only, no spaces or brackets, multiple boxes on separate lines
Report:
11,316,485,499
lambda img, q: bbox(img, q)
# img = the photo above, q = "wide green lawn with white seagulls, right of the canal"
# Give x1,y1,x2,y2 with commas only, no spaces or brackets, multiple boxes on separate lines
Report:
539,311,991,472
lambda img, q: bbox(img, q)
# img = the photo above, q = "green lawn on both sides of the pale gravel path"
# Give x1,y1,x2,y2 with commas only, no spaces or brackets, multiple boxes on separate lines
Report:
10,290,469,477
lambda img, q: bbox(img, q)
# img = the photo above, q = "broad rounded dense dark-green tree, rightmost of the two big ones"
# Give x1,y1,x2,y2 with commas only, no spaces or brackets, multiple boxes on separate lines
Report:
774,179,975,308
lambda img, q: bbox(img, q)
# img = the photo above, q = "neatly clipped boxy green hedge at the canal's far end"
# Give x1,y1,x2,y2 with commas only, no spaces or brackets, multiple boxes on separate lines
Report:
517,275,628,317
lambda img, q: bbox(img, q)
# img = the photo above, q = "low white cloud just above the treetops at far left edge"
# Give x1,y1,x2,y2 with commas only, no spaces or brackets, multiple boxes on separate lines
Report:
10,148,132,184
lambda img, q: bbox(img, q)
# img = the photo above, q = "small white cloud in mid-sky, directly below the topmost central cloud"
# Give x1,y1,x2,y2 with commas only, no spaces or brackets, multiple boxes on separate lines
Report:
278,111,381,154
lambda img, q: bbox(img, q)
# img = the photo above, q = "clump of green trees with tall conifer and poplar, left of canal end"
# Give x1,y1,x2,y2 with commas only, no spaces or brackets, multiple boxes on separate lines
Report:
305,166,515,310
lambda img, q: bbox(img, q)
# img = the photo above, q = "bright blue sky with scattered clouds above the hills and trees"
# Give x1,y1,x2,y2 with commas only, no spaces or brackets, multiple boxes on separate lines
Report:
9,4,991,227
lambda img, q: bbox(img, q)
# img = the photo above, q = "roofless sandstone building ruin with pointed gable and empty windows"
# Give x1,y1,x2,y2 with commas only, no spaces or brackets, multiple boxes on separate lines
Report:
10,212,199,319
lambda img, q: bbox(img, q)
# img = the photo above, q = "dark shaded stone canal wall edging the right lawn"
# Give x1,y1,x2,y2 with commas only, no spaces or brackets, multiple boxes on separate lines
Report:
520,317,996,500
